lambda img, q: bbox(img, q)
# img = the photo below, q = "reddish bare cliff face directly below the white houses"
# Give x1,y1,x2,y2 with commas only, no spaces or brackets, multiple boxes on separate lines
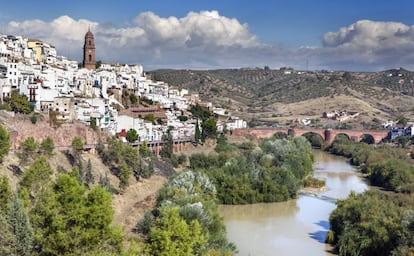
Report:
0,111,107,149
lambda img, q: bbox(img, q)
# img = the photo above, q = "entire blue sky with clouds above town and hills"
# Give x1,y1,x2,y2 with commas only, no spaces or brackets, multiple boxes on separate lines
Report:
0,0,414,71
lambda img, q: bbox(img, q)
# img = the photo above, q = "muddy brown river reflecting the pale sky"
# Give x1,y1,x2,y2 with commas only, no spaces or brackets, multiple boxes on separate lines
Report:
220,150,368,256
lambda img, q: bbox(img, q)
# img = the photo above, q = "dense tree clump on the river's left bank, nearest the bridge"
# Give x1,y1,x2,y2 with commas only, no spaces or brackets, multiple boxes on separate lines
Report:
190,137,313,204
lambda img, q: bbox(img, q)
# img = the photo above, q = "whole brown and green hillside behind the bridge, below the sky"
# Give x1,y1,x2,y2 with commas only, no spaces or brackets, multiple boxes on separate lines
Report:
149,68,414,128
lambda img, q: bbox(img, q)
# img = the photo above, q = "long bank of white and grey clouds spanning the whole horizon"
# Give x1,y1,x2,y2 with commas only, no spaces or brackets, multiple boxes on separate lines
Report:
2,14,414,70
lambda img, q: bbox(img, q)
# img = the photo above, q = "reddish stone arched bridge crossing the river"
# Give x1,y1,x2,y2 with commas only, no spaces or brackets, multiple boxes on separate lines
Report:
232,128,388,145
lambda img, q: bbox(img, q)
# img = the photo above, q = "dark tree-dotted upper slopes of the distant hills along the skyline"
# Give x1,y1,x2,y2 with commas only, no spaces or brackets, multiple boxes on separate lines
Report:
149,68,414,109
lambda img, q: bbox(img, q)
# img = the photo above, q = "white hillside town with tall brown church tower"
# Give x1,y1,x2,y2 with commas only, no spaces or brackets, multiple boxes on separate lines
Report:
0,31,247,146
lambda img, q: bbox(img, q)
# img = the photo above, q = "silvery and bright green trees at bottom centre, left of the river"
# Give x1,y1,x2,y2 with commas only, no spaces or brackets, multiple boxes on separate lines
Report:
136,171,235,255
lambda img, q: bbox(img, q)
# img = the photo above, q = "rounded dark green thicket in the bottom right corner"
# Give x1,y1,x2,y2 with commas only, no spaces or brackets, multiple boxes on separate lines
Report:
327,191,414,256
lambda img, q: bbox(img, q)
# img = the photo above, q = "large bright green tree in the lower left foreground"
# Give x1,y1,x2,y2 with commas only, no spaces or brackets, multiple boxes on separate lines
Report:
32,174,123,255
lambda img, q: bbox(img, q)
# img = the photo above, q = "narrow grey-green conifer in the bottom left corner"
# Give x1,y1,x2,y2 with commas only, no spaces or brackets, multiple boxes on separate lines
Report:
9,194,34,256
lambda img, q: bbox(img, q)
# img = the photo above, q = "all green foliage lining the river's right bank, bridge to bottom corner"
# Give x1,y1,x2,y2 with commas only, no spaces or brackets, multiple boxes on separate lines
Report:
326,139,414,256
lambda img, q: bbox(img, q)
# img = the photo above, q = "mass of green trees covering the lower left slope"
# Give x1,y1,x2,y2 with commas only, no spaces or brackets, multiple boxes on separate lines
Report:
0,135,139,256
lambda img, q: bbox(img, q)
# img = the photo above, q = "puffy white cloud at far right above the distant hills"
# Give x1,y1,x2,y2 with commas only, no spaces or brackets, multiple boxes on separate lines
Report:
321,20,414,70
